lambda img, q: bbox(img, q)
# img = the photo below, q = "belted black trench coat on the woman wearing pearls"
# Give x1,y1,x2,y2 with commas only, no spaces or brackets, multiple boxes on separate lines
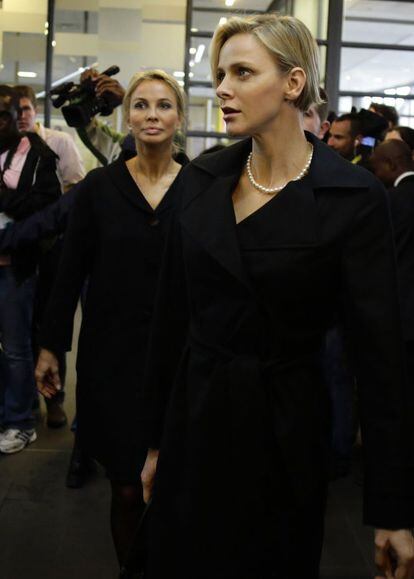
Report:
145,135,414,579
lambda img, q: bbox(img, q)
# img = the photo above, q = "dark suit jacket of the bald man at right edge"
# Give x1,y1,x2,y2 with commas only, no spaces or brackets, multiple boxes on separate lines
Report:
389,175,414,340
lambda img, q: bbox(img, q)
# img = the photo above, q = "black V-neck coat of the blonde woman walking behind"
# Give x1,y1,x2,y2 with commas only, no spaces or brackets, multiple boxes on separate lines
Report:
40,157,184,483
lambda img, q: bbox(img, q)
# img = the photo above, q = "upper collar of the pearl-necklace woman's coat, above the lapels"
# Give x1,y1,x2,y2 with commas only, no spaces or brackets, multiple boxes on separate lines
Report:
191,131,372,189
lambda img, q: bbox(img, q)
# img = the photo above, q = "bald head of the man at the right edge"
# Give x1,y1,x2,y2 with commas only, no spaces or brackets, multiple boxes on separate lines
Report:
371,139,414,187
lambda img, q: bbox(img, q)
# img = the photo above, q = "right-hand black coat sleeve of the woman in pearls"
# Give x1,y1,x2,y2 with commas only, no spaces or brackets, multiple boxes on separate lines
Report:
343,180,414,529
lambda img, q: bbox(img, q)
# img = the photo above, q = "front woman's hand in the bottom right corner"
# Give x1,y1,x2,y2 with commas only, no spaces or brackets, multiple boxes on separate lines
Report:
375,529,414,579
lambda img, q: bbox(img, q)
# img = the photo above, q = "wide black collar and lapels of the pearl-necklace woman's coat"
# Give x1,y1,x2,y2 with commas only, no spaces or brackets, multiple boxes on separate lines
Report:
180,133,374,290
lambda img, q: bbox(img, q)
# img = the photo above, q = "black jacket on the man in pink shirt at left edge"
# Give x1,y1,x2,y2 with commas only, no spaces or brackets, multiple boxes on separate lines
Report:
0,133,61,280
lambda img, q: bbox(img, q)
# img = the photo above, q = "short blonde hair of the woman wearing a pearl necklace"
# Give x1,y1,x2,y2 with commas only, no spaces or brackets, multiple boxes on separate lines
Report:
210,13,322,111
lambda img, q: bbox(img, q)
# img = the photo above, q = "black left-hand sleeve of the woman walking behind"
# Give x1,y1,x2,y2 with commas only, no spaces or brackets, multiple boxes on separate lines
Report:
39,174,97,353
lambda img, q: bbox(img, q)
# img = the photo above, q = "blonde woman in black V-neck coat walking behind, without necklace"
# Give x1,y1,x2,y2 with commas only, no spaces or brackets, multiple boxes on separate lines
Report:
36,70,184,564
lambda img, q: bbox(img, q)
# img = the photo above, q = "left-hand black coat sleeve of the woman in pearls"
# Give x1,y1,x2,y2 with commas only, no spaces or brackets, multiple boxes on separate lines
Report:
143,196,189,448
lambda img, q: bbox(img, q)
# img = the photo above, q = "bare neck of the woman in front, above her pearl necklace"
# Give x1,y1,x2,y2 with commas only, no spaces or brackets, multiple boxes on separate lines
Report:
252,115,310,187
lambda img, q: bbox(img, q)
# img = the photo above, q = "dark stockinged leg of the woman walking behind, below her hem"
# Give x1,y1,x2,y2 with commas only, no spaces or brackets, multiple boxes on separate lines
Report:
111,481,145,566
